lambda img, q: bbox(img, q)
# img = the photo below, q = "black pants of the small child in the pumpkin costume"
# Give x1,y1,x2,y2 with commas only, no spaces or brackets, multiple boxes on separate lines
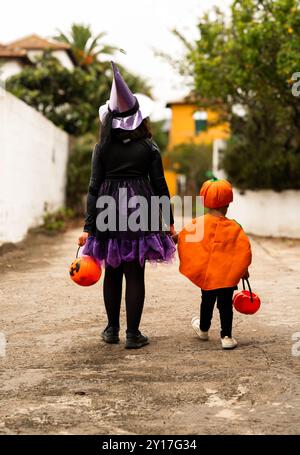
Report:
200,288,236,338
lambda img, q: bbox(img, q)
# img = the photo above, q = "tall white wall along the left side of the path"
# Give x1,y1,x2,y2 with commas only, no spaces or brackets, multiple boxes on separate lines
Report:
0,92,69,245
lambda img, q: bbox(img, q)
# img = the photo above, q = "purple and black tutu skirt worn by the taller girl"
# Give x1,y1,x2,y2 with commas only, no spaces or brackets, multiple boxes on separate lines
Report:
83,179,176,267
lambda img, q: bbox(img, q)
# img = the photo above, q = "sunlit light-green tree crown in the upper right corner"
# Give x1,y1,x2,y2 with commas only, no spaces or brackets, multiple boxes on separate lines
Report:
189,0,300,104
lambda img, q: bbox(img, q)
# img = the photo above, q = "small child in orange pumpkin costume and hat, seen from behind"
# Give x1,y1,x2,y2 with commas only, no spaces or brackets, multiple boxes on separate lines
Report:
178,179,251,349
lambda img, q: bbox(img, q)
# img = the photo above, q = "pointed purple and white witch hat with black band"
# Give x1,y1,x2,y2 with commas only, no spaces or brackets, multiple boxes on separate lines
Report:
99,62,152,130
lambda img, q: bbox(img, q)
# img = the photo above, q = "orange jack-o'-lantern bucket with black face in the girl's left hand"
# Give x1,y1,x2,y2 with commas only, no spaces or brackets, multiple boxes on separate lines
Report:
69,247,102,286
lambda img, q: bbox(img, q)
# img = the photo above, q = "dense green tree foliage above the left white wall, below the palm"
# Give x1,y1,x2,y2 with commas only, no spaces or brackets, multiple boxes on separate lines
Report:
7,52,149,136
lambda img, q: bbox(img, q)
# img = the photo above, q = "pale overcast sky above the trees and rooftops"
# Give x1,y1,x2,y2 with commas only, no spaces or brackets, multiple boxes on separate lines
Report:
0,0,230,117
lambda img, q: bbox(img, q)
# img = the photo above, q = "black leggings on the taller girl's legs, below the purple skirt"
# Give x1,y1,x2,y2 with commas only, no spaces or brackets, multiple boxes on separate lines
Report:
103,261,145,333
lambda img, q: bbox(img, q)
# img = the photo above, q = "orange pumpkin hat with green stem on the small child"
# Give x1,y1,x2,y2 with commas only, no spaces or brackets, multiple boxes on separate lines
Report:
200,178,233,209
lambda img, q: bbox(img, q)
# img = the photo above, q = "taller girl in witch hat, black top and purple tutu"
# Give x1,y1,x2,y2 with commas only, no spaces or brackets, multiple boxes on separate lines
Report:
78,62,176,349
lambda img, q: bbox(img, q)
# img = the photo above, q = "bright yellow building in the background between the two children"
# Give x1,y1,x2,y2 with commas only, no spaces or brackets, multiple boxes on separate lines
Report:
165,96,229,196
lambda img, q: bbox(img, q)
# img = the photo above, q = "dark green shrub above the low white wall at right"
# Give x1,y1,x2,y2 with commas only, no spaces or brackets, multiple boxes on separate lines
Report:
220,110,300,191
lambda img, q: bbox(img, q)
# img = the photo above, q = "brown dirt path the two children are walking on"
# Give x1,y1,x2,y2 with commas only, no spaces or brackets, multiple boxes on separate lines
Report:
0,230,300,434
